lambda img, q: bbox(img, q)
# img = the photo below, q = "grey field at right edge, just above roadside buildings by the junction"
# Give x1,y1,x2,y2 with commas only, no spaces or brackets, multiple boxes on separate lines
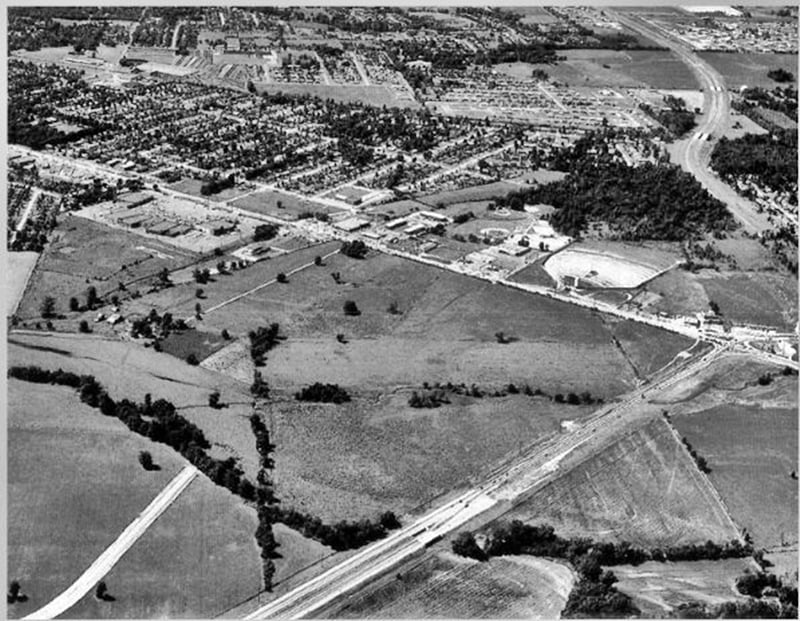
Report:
698,271,797,329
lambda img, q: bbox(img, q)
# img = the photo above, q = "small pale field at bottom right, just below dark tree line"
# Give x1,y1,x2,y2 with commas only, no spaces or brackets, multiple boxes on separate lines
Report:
610,558,755,618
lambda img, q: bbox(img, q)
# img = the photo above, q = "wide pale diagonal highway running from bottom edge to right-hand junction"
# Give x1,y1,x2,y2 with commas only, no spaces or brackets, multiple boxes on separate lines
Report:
245,346,728,619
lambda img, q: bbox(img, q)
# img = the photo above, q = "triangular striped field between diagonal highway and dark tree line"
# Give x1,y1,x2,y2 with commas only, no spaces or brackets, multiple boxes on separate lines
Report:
496,419,737,547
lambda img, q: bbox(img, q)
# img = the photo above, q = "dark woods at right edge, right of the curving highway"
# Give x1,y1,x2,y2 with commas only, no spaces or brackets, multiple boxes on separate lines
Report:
711,130,797,192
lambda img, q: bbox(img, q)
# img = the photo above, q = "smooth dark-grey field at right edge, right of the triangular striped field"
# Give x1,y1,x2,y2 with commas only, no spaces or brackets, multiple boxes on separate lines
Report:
673,398,798,548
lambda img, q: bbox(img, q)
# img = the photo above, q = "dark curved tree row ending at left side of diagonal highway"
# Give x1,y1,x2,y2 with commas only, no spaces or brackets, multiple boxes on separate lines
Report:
267,506,400,552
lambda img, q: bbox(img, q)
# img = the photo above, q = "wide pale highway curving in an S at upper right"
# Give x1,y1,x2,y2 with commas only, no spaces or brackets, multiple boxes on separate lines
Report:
613,12,771,233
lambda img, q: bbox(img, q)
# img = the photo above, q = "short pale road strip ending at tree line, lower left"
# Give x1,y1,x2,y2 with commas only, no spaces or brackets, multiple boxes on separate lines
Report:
24,466,200,619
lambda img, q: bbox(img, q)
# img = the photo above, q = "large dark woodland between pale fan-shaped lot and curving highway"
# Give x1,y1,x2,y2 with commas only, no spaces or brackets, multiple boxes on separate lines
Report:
497,161,735,241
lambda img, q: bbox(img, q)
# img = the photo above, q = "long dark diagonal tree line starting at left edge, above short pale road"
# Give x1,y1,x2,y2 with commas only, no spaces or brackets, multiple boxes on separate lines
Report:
8,366,264,501
